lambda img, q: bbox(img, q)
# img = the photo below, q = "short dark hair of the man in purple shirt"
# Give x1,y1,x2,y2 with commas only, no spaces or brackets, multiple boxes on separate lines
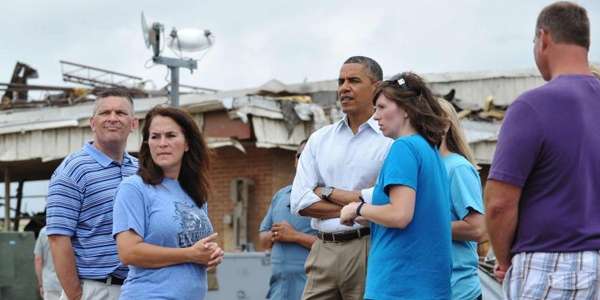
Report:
535,1,590,50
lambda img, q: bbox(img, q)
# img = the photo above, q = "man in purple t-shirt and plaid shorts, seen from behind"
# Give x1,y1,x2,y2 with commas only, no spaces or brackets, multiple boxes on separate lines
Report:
485,2,600,299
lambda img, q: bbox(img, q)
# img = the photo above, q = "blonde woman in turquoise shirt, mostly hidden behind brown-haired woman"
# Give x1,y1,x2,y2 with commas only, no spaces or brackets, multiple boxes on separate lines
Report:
440,99,486,300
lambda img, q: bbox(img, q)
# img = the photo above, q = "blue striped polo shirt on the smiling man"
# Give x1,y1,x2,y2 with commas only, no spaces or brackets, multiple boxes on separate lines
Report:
46,142,138,279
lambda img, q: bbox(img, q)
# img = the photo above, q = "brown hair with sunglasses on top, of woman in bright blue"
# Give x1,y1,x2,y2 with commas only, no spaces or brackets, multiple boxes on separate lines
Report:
373,72,448,147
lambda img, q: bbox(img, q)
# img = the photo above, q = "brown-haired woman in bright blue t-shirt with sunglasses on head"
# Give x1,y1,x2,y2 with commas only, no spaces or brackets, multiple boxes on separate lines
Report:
340,73,452,300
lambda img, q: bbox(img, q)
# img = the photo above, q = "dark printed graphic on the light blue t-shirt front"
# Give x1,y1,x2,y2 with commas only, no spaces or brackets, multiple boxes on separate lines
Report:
175,202,213,248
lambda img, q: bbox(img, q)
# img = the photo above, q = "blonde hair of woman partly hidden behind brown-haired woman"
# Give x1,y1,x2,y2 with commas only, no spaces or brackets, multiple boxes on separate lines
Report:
438,98,477,167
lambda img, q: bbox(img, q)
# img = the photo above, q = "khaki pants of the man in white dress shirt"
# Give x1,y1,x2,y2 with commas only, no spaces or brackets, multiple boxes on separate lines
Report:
303,235,371,300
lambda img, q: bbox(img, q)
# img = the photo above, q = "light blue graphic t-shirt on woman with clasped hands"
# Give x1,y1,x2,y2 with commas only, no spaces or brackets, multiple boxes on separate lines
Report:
113,175,213,300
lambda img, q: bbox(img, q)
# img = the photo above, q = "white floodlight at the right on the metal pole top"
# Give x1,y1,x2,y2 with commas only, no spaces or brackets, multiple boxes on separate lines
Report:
167,28,215,52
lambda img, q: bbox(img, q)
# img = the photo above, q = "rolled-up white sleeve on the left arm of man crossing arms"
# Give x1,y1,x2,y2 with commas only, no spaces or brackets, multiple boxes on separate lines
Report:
290,138,322,216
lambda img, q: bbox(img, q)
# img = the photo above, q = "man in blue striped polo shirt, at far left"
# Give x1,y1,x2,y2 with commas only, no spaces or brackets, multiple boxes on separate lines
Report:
46,89,138,300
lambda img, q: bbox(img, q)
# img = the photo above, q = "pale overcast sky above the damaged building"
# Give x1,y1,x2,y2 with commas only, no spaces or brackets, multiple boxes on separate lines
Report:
0,0,600,94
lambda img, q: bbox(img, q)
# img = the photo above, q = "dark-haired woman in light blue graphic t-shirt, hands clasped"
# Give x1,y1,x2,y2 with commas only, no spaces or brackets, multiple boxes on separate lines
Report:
113,106,223,300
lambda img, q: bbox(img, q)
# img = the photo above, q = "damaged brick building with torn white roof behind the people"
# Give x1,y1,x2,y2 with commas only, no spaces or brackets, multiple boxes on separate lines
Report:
0,63,543,251
